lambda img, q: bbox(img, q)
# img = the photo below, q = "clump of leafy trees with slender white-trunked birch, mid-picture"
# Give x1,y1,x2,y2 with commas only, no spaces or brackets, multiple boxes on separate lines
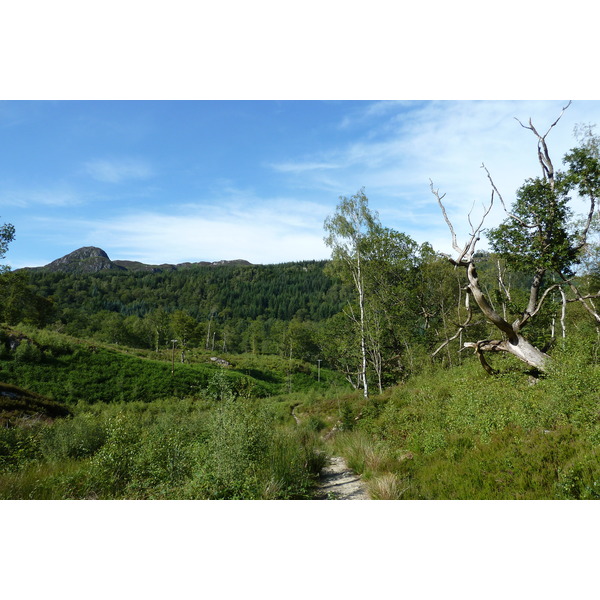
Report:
321,190,432,391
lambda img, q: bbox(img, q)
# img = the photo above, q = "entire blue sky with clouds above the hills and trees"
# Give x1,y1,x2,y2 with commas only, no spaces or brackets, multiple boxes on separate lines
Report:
0,100,600,268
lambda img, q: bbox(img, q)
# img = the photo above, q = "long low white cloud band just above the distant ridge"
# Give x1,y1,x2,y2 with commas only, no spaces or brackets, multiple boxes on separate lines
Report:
29,199,330,264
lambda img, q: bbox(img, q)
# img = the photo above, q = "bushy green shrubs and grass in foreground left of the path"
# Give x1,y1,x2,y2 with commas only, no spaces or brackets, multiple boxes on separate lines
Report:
0,386,325,499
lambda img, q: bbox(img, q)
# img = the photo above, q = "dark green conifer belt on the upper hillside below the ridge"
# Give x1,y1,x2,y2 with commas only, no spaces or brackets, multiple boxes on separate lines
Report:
29,261,348,321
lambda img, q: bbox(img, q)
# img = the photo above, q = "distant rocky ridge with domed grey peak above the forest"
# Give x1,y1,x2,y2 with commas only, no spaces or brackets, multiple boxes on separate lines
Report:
23,246,252,273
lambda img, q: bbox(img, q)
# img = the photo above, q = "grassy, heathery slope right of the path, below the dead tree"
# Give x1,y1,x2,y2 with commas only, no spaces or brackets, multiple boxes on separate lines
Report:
322,340,600,499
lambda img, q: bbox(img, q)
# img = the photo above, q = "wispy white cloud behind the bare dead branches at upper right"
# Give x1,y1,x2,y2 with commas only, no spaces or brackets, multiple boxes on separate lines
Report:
274,101,600,251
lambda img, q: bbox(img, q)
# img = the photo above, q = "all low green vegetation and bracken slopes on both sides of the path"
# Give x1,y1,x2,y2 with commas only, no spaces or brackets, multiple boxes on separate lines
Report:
0,324,600,499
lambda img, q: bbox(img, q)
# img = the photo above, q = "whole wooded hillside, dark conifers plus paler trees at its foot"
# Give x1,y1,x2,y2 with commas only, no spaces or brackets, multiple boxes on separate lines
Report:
22,261,347,352
